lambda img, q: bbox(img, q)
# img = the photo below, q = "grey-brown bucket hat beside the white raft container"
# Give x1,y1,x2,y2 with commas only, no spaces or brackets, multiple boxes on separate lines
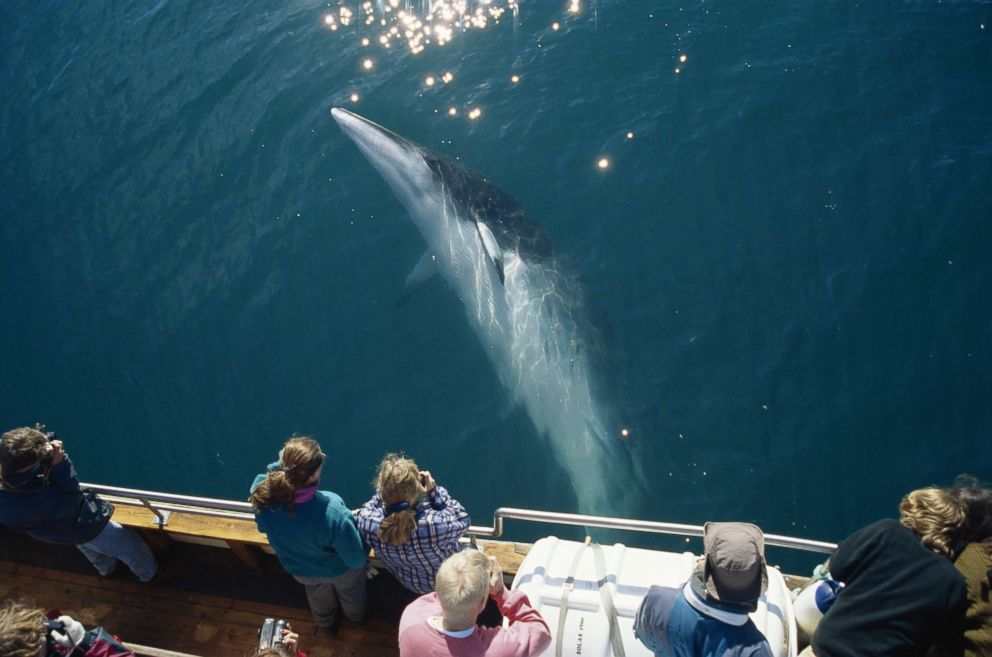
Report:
694,522,768,611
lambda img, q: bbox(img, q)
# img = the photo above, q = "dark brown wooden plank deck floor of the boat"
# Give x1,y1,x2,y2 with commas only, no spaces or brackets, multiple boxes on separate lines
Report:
0,534,413,657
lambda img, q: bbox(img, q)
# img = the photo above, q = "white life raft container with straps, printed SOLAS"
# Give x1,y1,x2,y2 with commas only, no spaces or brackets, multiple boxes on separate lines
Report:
513,536,796,657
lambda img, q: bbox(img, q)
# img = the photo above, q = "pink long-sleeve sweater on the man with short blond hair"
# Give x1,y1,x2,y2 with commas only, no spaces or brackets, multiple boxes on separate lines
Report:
400,589,551,657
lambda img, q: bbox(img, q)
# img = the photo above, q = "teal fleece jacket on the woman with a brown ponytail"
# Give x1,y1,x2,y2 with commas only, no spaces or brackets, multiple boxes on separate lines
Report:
251,463,368,577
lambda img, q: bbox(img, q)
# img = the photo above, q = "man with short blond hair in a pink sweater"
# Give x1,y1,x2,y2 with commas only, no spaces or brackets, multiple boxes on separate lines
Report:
400,550,551,657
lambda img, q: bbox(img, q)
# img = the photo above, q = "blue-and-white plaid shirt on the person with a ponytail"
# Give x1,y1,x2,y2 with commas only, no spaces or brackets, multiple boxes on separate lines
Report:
357,486,470,594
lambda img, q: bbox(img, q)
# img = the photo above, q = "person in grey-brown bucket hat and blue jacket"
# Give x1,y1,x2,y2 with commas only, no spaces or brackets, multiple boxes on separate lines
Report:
634,522,772,657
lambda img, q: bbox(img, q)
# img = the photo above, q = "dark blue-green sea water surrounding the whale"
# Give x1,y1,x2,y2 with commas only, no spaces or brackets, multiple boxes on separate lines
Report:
0,0,992,568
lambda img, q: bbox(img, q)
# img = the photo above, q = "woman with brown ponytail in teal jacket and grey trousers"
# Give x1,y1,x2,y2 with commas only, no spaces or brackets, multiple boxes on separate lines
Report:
251,437,368,627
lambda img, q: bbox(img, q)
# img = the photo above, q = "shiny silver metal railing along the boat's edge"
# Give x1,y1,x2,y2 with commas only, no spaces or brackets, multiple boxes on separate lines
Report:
82,484,837,553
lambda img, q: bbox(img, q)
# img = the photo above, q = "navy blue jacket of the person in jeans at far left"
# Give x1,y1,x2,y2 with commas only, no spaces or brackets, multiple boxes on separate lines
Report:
0,457,113,545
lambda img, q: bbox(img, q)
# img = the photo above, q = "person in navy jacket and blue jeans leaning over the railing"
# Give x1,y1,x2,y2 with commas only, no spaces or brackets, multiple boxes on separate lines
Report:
0,425,178,584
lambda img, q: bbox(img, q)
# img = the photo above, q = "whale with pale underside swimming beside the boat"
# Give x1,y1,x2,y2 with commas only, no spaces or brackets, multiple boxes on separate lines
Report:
331,108,642,513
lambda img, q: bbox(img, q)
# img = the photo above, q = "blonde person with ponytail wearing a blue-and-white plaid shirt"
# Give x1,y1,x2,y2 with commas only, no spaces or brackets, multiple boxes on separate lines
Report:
358,454,471,594
